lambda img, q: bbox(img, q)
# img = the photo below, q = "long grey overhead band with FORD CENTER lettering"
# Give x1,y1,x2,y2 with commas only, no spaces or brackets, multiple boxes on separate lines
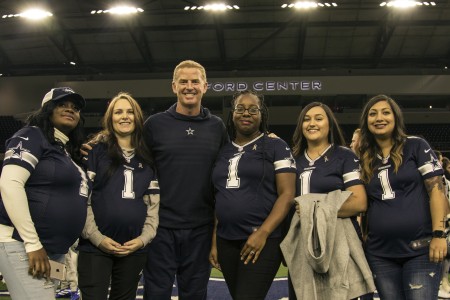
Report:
51,75,450,98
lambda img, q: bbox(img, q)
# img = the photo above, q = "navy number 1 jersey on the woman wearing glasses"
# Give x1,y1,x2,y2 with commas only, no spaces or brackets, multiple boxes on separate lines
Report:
213,135,296,240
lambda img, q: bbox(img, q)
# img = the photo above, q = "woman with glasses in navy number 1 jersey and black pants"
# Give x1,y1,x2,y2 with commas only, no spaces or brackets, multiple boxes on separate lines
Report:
210,91,295,300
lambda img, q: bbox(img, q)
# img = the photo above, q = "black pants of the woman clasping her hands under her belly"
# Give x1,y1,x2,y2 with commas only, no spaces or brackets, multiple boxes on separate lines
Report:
78,251,147,300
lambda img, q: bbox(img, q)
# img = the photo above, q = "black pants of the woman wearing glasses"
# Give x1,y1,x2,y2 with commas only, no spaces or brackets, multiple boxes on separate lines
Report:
217,237,282,300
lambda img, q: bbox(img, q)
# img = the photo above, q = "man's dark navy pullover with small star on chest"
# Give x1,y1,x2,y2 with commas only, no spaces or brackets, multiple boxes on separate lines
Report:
145,104,228,229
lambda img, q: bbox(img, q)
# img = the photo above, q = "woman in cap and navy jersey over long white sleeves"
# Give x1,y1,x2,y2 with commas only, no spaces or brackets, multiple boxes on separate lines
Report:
0,87,88,300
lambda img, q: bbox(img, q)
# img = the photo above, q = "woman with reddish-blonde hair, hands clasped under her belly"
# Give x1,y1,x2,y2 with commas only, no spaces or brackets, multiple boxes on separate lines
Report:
78,93,159,300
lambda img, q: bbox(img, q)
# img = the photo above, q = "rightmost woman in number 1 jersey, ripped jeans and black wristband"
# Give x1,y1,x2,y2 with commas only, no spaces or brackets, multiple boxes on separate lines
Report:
360,95,448,300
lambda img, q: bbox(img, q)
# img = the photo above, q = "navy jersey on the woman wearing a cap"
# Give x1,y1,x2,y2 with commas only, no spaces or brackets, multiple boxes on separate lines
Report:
0,127,88,254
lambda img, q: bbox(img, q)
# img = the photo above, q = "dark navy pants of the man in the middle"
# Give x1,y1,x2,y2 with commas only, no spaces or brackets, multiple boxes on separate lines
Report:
144,225,213,300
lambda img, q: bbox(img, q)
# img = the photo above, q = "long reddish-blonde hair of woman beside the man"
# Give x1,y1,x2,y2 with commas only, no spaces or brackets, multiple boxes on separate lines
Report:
91,92,153,177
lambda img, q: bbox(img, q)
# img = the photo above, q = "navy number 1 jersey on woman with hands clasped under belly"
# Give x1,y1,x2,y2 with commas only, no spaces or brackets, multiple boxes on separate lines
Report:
79,143,159,252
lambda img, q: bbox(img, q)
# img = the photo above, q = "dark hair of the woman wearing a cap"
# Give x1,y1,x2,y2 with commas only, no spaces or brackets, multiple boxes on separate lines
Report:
26,100,85,165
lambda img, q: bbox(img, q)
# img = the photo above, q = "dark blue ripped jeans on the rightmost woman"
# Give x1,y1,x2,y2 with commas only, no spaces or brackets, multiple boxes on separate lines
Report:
366,253,442,300
